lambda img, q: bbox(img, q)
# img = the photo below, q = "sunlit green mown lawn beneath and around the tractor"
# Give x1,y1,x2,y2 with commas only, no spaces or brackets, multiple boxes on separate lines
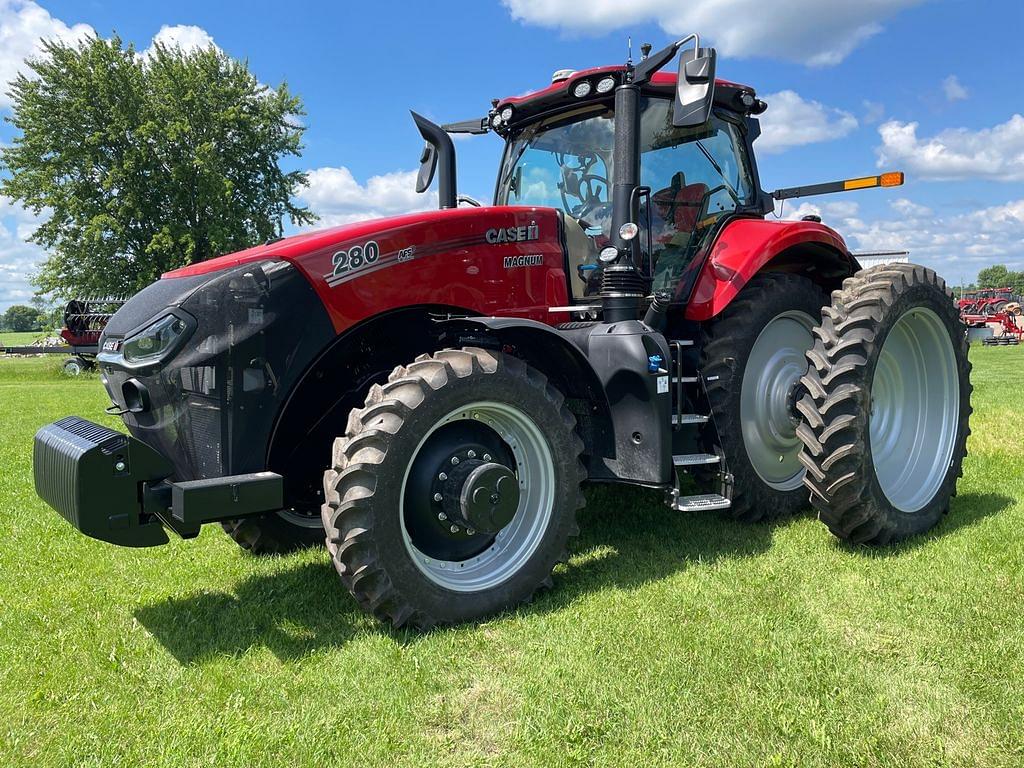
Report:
0,348,1024,768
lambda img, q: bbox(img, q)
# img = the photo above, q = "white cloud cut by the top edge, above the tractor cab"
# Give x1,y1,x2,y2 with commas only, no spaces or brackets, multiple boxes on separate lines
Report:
503,0,922,67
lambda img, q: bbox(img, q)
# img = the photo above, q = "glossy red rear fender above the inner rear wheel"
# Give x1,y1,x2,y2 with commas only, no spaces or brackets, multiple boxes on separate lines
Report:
685,219,860,322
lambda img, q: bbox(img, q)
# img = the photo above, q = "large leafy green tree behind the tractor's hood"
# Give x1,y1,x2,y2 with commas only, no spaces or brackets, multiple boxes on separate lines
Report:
0,36,315,297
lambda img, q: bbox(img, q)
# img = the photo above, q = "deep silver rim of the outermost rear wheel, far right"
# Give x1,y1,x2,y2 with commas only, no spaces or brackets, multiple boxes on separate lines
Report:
868,307,959,512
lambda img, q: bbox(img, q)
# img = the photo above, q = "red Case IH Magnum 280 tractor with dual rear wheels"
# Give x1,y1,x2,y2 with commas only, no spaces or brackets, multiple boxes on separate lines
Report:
35,36,971,628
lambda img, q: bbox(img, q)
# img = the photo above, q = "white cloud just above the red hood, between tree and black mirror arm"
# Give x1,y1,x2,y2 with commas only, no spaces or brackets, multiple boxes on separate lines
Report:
300,166,437,226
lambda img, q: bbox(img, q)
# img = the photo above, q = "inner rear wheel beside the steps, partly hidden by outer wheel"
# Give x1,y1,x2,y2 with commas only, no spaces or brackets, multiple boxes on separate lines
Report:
700,272,825,522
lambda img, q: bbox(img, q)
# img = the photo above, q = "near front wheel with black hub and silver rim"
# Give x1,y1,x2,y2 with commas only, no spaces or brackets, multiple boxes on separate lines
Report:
323,347,585,629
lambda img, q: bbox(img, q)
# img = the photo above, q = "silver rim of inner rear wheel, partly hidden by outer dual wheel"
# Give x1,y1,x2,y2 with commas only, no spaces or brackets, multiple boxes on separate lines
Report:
739,310,815,490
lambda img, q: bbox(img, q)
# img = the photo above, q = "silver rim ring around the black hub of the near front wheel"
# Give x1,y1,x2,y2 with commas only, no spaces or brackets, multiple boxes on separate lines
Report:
398,400,555,592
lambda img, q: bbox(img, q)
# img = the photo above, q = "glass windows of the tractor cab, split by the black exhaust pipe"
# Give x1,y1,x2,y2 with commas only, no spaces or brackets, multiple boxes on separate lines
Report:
496,96,754,298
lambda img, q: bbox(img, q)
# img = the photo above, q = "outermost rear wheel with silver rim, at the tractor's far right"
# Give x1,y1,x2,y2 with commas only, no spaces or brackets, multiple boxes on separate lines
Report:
798,264,972,545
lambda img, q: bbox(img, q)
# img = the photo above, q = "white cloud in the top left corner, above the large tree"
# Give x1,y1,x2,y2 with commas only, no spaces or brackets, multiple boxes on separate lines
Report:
0,0,95,109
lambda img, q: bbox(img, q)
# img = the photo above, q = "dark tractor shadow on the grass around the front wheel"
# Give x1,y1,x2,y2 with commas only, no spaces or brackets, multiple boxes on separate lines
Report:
135,485,774,665
